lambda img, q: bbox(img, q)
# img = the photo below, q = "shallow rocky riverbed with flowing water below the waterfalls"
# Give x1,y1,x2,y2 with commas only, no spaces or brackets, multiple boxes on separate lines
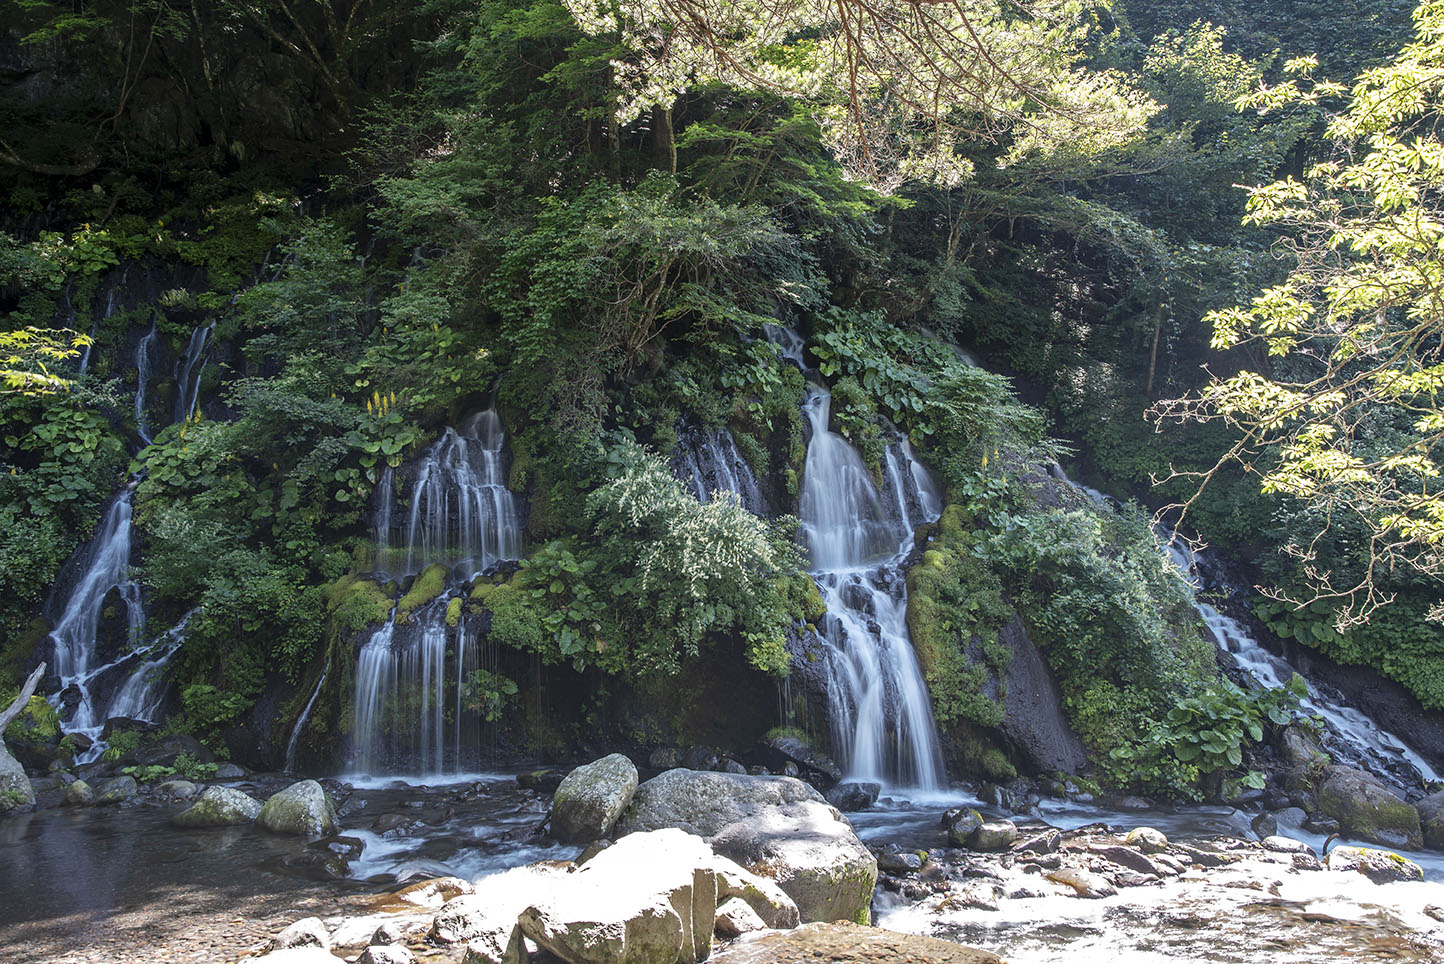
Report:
0,771,1444,964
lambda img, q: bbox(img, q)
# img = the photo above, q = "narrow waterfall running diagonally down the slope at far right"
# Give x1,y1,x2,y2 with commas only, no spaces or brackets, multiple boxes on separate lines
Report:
1048,465,1444,781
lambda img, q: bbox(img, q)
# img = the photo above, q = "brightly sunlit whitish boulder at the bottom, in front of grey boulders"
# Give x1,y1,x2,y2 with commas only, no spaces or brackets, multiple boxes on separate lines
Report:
518,830,718,964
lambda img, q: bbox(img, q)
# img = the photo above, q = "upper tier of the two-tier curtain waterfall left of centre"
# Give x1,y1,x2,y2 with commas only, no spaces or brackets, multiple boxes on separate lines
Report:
401,408,521,576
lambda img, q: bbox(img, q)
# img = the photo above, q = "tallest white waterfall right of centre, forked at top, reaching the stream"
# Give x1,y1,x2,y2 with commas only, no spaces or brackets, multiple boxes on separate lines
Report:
799,387,944,789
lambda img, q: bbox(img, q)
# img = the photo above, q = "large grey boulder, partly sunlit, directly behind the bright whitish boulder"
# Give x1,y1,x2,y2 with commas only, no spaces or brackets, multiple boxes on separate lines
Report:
617,769,878,922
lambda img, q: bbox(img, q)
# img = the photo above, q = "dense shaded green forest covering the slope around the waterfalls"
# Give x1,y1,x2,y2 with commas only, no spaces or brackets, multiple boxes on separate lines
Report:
0,0,1444,795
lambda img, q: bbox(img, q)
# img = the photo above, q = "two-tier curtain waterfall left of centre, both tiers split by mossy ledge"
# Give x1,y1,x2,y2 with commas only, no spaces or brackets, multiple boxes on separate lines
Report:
351,410,521,774
